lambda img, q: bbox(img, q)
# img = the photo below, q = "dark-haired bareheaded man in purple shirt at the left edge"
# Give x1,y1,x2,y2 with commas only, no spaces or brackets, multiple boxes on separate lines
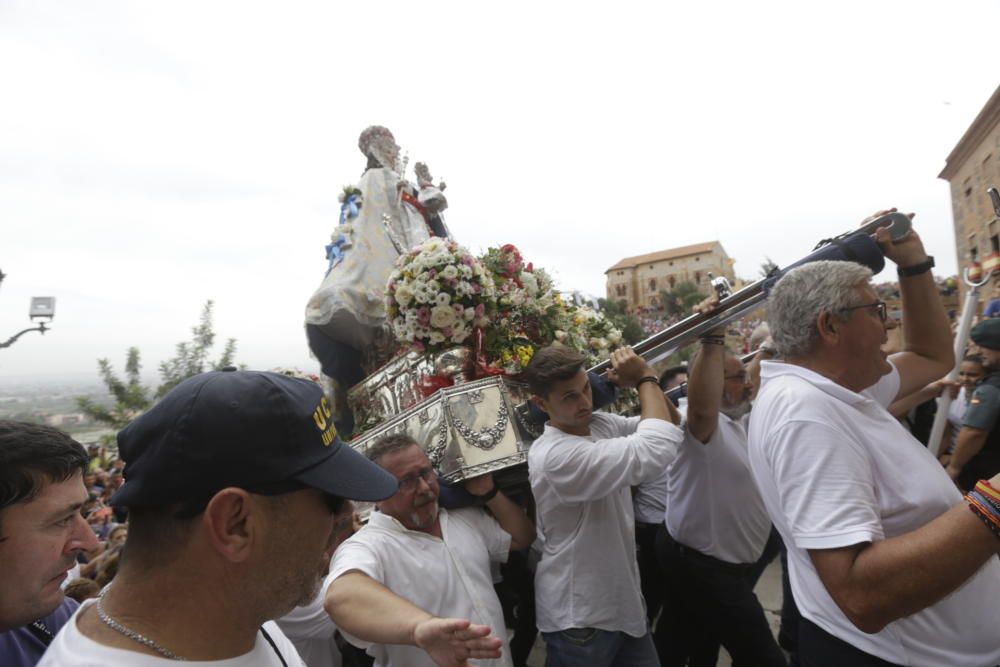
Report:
0,420,97,667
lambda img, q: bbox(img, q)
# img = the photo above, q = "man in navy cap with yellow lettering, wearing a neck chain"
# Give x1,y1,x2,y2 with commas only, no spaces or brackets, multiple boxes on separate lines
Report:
40,368,396,667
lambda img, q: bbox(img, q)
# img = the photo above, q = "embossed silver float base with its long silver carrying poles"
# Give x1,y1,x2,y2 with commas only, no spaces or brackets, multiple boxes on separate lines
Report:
348,213,910,484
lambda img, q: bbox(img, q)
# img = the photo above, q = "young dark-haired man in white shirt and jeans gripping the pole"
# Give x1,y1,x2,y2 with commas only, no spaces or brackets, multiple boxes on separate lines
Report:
526,344,682,667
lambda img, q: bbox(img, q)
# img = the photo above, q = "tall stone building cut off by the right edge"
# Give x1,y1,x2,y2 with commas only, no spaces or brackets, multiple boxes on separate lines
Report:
938,88,1000,272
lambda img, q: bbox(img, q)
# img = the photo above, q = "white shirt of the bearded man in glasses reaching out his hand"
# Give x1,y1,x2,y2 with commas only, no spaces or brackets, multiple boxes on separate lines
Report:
328,507,513,667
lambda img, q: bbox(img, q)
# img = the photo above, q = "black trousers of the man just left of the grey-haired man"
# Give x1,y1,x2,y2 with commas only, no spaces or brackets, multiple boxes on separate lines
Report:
656,526,786,667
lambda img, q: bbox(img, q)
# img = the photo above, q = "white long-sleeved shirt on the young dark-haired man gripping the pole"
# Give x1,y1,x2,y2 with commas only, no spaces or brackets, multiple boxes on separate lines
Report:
528,412,683,637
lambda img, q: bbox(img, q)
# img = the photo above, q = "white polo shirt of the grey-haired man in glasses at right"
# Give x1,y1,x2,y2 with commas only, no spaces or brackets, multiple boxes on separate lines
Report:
750,361,1000,667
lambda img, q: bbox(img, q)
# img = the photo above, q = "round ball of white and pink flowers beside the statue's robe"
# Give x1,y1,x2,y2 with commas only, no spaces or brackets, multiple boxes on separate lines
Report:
386,238,495,352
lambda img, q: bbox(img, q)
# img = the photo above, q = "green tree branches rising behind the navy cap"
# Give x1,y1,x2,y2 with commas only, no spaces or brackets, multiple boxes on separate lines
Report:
76,301,236,444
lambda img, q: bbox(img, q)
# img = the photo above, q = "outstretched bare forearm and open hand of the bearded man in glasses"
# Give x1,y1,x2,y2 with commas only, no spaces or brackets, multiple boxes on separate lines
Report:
323,570,502,667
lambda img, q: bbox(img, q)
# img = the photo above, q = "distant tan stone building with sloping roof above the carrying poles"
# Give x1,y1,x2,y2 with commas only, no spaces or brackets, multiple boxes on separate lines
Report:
604,241,735,309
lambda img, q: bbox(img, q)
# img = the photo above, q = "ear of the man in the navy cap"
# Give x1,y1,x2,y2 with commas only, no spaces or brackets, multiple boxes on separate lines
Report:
202,487,264,563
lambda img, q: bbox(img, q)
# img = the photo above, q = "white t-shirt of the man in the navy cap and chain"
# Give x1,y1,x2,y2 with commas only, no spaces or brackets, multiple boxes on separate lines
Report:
38,600,305,667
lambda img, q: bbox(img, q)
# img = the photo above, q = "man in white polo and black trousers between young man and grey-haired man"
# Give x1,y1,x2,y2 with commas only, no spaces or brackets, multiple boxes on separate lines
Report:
657,334,785,667
